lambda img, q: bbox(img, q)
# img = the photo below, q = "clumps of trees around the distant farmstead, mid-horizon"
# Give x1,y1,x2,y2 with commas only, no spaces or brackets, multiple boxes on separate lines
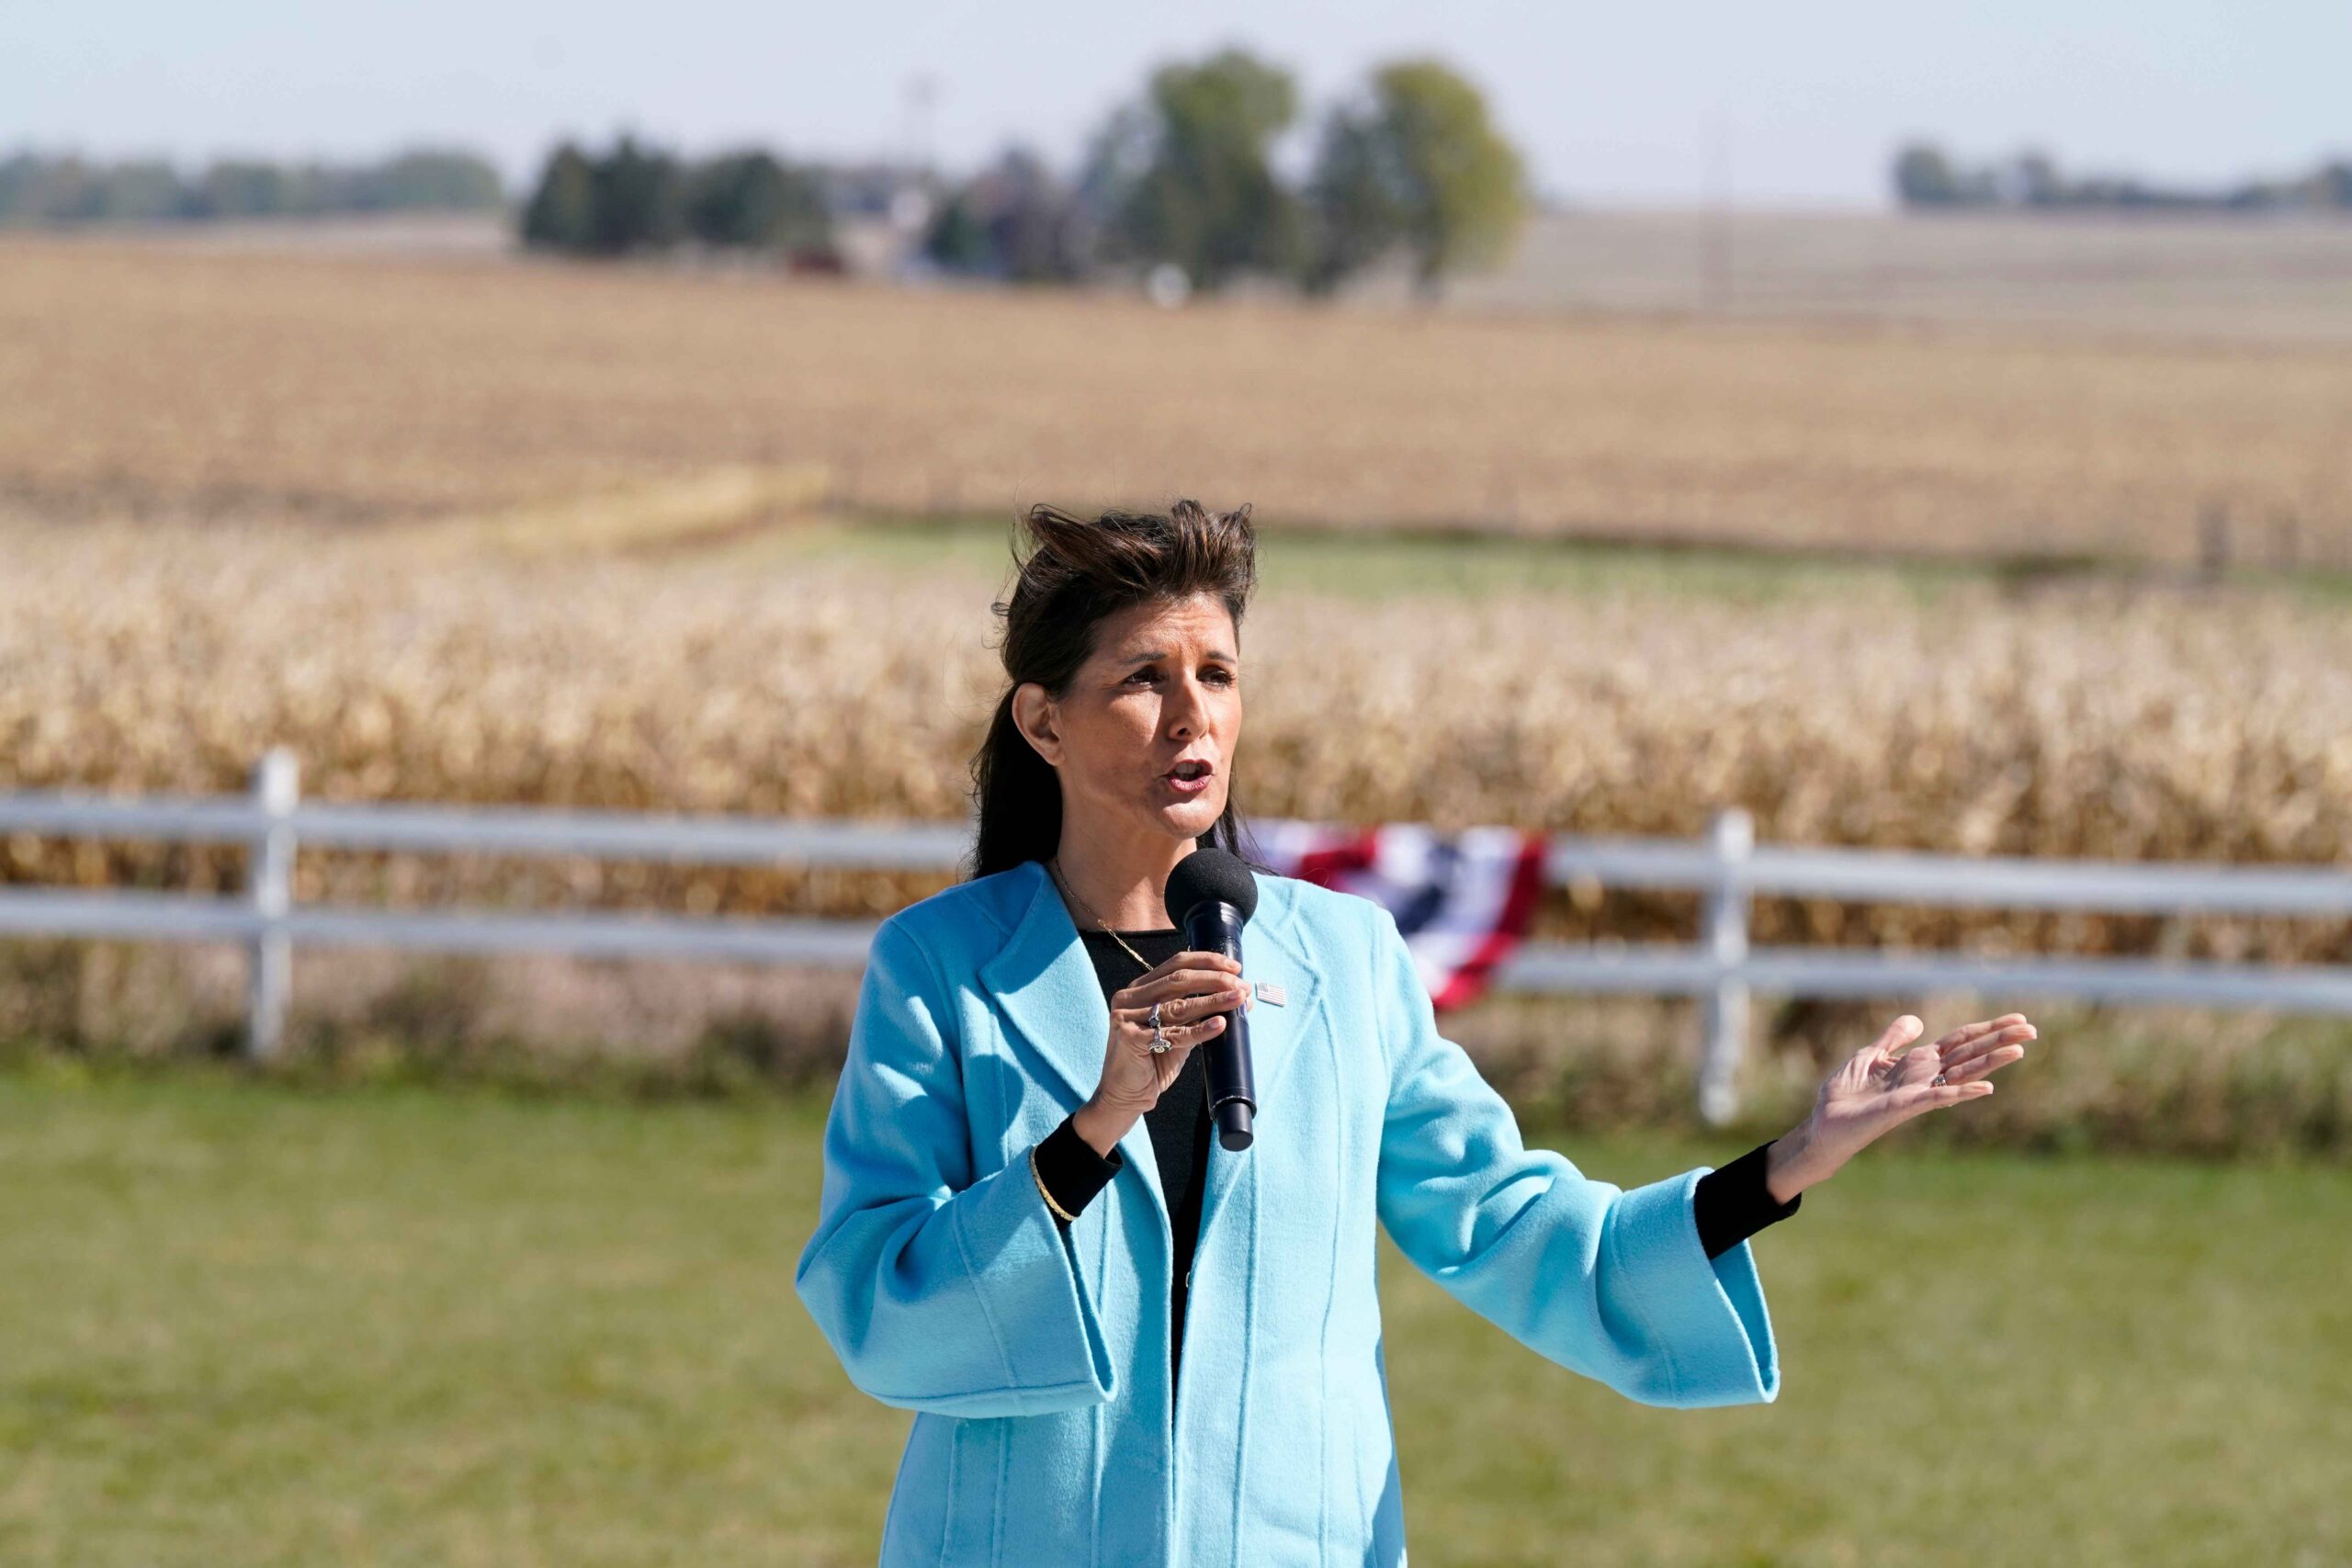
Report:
522,47,1533,294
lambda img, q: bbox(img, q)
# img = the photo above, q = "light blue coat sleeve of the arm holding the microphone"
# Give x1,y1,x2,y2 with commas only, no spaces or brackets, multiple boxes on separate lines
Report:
793,917,1120,1416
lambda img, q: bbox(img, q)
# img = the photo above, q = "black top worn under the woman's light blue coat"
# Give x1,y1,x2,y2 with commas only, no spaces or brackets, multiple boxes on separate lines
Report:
1037,929,1804,1389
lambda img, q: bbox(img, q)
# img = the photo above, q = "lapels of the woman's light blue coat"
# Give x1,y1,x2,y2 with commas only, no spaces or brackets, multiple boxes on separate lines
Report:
981,861,1322,1236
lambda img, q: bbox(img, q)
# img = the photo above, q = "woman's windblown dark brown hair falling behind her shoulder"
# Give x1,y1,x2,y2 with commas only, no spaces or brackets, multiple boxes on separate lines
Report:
969,501,1272,879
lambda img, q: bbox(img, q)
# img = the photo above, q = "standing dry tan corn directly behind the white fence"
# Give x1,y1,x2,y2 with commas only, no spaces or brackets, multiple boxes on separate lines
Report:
0,512,2352,962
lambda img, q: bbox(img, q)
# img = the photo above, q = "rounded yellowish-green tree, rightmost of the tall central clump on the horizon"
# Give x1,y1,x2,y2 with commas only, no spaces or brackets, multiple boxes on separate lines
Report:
1306,59,1533,296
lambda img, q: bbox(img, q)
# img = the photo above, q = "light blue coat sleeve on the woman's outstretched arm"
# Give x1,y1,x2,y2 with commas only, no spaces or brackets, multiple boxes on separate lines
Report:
1371,903,1781,1408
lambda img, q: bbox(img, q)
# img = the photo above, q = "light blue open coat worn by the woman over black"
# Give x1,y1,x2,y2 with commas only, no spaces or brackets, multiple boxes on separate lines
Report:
795,861,1781,1568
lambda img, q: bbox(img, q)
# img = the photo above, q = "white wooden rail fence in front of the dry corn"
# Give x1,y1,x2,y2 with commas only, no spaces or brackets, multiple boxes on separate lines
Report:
0,750,2352,1123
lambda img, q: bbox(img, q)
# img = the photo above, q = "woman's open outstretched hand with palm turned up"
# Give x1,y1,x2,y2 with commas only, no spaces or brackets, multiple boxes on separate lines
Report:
1764,1013,2037,1203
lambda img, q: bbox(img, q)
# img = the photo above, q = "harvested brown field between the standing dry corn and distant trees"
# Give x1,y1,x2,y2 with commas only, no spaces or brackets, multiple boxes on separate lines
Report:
14,237,2352,564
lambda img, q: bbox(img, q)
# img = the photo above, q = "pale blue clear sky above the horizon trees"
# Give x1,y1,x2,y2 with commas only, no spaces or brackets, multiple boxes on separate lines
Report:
0,0,2352,207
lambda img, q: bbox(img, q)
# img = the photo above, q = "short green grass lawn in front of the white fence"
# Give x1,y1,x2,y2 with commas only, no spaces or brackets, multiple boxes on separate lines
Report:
0,1060,2352,1568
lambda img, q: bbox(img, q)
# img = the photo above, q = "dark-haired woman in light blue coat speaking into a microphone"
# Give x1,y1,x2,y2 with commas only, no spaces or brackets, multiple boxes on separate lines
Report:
795,501,2034,1568
